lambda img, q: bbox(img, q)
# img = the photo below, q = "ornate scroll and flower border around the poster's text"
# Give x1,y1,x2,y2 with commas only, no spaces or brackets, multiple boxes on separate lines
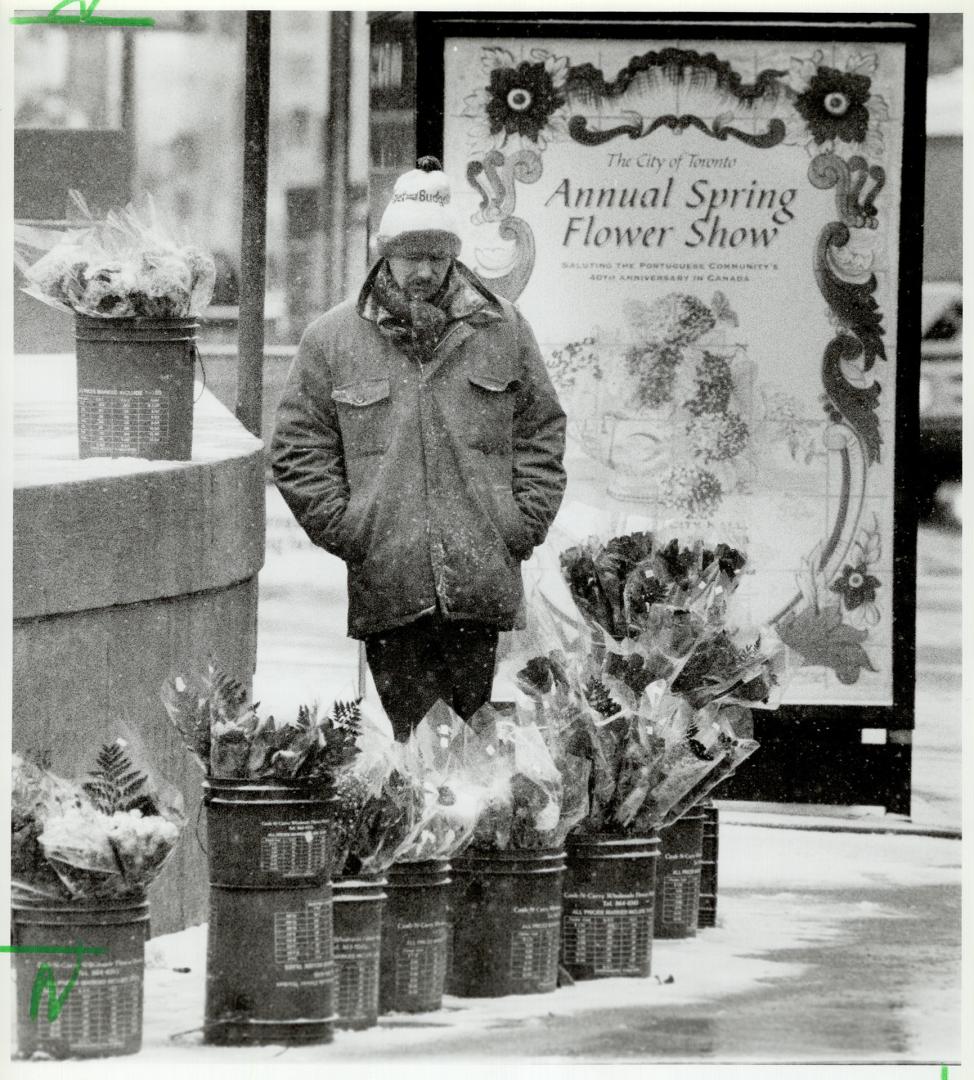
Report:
461,45,890,685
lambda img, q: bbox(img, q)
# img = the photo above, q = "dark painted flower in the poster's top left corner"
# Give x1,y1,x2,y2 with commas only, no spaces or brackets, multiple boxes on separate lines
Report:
461,46,568,150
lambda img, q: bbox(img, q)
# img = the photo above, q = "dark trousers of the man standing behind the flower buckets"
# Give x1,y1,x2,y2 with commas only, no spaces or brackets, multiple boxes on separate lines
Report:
365,615,498,742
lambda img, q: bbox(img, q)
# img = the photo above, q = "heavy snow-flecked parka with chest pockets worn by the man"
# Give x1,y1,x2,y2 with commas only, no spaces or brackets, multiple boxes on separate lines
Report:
271,269,565,637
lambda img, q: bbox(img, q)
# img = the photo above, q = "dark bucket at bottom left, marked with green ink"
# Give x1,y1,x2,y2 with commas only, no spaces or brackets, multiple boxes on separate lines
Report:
12,899,149,1058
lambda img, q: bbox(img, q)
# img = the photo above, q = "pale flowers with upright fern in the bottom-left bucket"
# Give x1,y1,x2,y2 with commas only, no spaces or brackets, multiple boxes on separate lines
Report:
11,739,186,901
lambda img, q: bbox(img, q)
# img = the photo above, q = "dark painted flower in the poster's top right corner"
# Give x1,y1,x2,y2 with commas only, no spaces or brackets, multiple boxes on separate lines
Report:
789,50,890,158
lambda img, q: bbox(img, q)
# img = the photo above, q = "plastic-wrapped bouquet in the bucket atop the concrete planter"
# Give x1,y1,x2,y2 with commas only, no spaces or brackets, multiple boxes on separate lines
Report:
16,191,216,319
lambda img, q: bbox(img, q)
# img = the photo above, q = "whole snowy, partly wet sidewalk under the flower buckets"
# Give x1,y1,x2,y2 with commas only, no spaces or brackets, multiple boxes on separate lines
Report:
125,824,961,1062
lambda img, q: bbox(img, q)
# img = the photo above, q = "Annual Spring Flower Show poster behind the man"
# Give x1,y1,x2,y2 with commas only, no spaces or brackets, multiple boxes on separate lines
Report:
443,36,905,706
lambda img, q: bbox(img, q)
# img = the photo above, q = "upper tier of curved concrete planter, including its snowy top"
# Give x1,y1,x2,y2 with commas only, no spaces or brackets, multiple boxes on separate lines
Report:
13,355,271,619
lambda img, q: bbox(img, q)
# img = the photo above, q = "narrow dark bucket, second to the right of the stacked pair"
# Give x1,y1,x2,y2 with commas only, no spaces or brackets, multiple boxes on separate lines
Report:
379,859,450,1013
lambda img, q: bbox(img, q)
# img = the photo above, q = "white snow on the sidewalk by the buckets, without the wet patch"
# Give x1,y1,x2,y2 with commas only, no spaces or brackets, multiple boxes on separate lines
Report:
62,825,960,1077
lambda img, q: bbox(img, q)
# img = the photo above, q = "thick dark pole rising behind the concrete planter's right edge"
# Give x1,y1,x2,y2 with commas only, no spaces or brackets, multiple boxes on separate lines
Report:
236,11,271,437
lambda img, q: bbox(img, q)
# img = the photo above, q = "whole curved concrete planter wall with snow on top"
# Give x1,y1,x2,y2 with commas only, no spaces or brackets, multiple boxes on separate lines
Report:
13,356,265,933
